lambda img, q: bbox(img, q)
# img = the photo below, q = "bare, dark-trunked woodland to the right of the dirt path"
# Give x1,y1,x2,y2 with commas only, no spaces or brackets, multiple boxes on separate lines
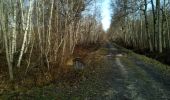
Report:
109,0,170,55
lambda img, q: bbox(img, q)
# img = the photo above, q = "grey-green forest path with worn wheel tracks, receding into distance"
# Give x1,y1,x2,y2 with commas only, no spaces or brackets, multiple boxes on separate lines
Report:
98,43,170,100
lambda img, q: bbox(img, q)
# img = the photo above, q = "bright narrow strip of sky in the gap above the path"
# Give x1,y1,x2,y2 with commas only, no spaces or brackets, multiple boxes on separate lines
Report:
101,0,112,31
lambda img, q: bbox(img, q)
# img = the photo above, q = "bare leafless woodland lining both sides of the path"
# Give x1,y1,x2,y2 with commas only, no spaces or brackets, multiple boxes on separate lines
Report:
0,0,170,86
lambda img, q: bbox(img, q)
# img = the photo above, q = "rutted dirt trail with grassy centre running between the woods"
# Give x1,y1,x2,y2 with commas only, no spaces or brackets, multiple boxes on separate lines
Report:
102,43,170,100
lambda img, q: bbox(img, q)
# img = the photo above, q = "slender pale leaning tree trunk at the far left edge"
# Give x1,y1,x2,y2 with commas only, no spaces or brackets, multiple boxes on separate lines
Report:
0,0,15,80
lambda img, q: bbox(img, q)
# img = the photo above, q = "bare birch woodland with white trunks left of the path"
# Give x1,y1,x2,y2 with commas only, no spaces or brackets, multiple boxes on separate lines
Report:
0,0,104,80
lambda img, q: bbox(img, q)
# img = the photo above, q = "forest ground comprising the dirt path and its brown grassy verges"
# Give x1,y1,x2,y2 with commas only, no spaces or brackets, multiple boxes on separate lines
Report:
0,43,170,100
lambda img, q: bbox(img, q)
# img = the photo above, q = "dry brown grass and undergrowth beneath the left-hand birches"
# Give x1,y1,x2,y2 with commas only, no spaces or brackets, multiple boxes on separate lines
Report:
0,44,100,94
